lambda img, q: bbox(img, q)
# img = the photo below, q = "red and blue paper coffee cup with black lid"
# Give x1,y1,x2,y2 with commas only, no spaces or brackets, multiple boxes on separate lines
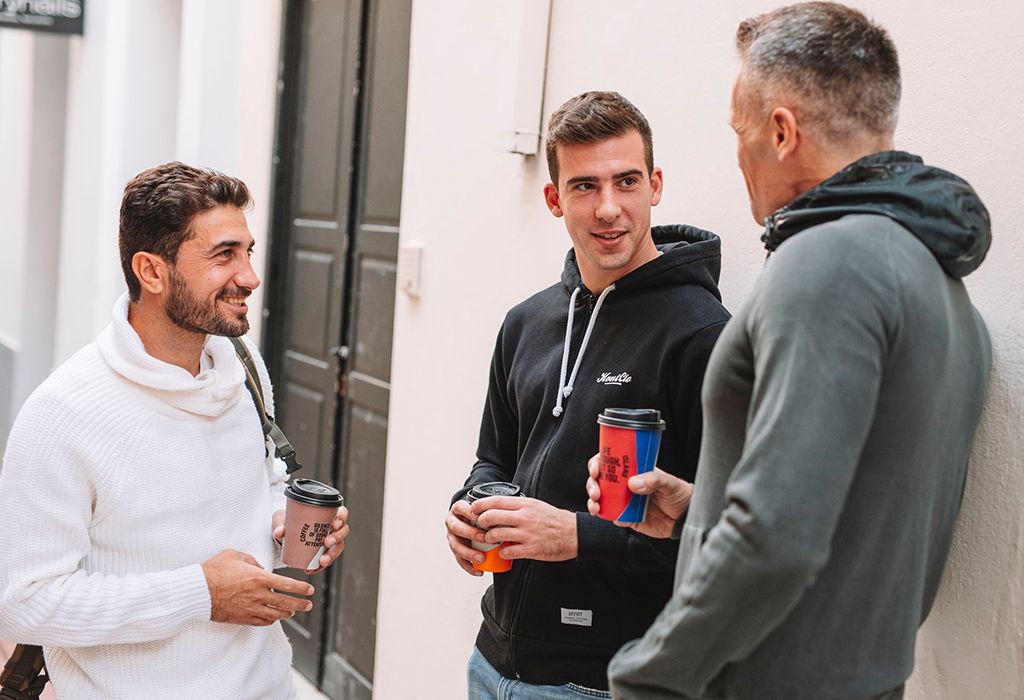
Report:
597,408,665,523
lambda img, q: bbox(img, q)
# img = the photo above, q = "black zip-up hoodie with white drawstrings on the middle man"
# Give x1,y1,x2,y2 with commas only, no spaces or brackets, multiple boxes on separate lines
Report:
453,225,729,689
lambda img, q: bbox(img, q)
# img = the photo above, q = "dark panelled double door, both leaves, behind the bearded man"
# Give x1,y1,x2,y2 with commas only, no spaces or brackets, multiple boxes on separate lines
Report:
263,0,412,700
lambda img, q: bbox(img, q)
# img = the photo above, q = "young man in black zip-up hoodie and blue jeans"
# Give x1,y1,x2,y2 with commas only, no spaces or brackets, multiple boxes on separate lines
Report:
446,92,729,700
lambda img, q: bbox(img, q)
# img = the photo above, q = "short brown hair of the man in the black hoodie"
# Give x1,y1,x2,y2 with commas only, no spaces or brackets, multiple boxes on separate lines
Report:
546,91,654,187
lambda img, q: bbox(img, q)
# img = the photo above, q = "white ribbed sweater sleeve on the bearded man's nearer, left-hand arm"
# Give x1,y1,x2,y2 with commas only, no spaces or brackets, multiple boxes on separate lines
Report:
0,392,210,647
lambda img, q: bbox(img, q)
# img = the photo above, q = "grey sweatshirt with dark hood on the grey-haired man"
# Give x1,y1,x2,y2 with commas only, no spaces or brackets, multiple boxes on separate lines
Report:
608,152,990,700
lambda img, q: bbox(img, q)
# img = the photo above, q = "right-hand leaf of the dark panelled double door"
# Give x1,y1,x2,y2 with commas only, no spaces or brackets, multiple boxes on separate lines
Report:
323,0,412,700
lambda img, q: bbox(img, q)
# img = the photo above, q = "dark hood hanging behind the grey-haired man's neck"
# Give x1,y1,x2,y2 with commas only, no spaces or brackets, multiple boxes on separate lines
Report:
762,150,992,278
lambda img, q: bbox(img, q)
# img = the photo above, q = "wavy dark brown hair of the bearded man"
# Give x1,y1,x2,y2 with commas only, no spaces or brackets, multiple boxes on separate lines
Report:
118,161,252,301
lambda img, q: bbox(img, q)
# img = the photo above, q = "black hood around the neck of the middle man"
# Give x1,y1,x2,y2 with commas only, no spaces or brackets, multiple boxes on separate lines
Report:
562,224,722,304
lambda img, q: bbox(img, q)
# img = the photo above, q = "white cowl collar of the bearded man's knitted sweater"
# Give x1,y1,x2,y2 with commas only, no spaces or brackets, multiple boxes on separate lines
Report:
96,293,245,418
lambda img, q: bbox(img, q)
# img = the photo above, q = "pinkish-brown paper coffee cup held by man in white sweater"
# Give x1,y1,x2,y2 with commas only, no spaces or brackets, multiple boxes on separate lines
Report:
281,479,345,571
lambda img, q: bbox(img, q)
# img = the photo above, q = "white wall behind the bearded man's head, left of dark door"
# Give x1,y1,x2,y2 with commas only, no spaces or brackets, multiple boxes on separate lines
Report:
46,0,281,364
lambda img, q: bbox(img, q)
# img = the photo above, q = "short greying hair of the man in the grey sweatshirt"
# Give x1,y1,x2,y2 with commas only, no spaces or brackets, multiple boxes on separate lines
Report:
736,2,901,142
